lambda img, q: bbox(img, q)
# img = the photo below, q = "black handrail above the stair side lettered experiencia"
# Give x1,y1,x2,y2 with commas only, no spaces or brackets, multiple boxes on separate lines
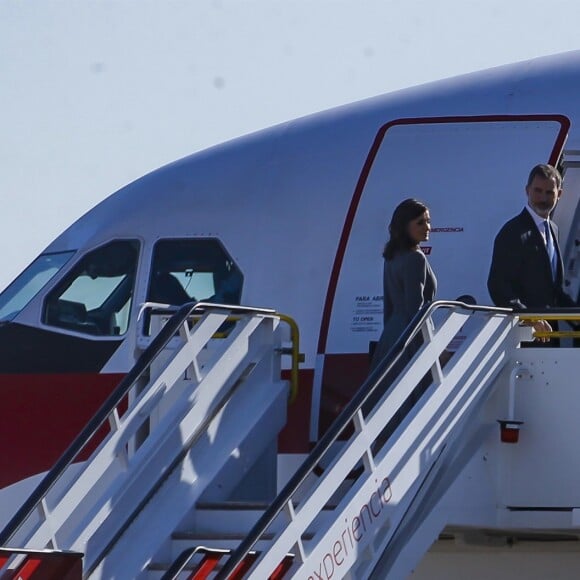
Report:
216,300,513,580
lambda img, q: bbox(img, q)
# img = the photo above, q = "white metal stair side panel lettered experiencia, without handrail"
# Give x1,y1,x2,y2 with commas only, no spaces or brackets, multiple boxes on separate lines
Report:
232,312,522,579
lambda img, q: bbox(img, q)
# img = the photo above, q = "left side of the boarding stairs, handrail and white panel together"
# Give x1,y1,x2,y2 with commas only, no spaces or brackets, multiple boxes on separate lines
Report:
0,303,297,580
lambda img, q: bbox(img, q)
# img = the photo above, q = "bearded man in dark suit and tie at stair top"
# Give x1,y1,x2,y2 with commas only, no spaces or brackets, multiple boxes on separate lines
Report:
487,165,576,330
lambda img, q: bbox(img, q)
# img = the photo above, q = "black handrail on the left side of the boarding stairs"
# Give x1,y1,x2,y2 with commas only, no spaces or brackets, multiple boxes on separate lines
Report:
0,302,277,547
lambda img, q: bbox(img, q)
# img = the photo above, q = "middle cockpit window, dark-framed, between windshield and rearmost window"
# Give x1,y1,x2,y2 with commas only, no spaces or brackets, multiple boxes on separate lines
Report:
43,240,139,336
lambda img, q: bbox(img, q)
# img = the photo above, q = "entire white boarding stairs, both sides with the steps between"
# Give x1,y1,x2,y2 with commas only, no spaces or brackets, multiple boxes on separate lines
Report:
0,302,531,580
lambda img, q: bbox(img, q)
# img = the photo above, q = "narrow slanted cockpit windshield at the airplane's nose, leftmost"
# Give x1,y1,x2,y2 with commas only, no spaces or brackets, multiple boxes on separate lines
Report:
0,251,74,321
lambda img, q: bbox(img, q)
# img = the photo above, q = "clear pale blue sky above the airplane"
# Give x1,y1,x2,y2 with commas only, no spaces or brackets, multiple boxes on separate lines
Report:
0,0,580,288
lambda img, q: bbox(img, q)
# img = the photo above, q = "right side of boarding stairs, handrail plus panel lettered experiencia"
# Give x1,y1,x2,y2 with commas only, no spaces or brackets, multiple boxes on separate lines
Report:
186,302,531,580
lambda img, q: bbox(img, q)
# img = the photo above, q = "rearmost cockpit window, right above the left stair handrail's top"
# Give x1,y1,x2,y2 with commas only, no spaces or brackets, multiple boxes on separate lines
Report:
147,238,243,306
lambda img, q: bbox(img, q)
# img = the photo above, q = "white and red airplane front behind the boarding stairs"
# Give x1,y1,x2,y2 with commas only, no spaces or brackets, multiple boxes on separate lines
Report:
0,51,580,578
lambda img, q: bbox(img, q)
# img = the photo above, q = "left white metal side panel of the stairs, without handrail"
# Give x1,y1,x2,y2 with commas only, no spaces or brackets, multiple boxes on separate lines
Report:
3,312,288,578
